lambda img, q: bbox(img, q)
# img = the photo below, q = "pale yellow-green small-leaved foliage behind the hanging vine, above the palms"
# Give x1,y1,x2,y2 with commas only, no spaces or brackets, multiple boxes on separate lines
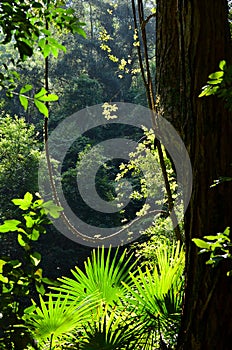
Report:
116,128,179,236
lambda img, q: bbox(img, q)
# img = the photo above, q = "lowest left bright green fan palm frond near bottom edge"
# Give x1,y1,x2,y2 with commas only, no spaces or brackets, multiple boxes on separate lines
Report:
24,294,97,349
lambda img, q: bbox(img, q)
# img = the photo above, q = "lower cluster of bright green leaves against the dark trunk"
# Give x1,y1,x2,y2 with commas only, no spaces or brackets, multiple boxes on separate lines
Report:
192,227,232,276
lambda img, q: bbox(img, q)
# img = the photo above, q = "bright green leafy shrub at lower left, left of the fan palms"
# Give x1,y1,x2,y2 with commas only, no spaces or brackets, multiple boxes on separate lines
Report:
0,192,61,349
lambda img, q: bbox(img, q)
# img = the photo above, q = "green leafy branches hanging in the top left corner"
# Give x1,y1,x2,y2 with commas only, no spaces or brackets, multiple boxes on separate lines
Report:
0,0,85,117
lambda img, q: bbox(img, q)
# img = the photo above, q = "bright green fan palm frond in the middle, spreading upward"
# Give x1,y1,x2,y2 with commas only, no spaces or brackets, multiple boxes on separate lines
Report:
52,247,135,306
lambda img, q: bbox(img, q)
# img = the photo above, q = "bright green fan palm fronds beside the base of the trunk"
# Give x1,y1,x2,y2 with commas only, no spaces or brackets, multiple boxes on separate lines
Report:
123,239,184,349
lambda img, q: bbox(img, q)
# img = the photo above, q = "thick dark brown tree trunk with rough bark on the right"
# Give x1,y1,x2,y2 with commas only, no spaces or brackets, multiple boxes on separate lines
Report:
156,0,232,350
